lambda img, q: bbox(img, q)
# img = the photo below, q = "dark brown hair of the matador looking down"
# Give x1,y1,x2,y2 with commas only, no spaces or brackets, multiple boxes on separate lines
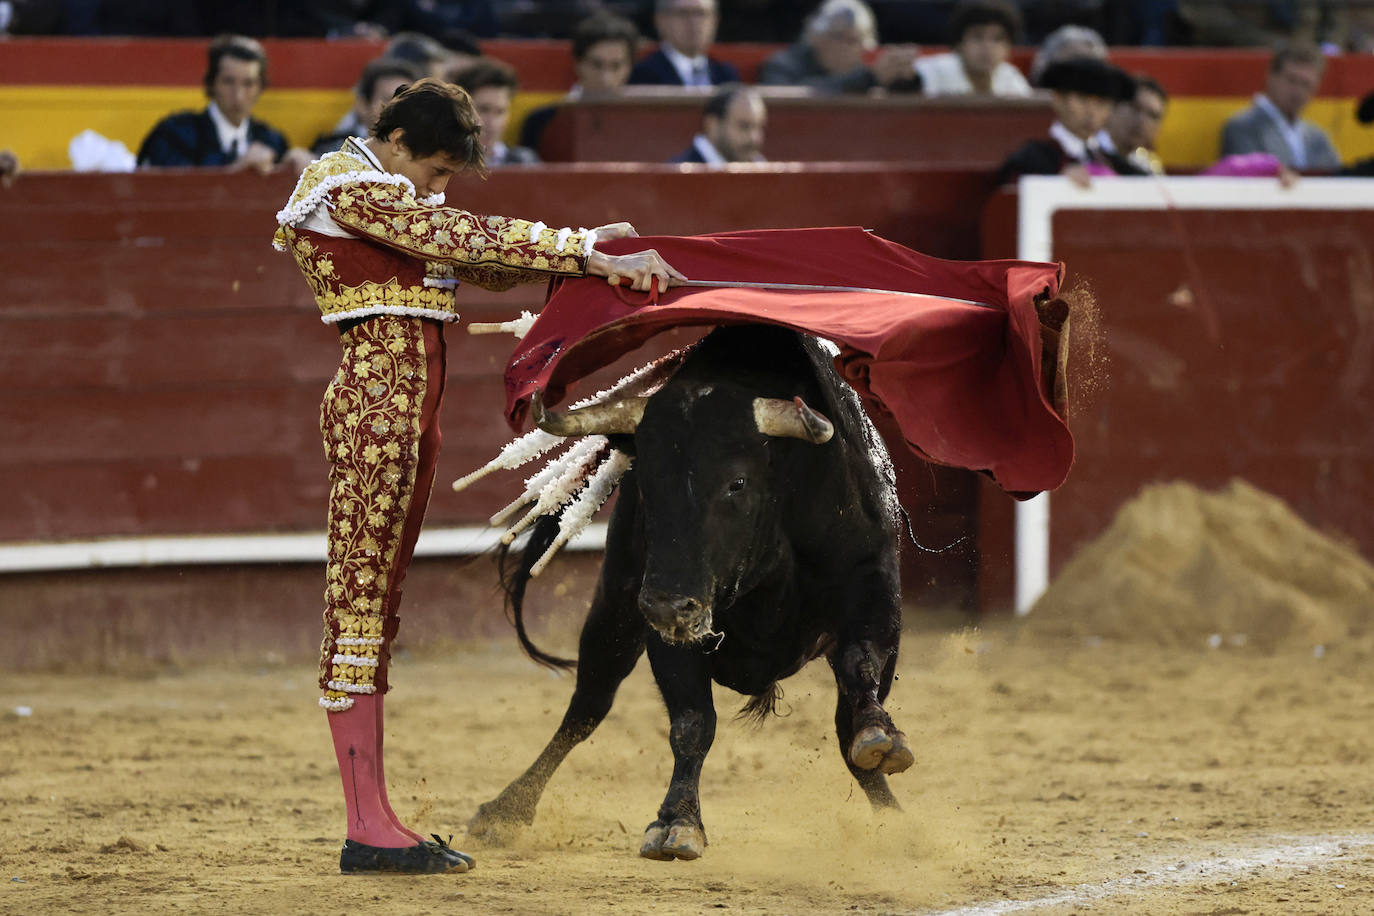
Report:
372,77,486,174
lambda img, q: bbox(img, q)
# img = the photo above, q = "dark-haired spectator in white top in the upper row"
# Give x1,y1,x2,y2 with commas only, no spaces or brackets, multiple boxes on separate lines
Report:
916,0,1031,96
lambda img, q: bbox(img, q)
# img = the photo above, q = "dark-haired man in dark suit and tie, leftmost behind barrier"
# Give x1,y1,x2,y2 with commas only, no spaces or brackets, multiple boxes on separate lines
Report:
139,34,311,172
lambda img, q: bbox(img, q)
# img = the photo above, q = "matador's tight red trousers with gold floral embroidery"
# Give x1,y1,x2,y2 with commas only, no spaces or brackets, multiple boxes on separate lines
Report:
320,314,445,711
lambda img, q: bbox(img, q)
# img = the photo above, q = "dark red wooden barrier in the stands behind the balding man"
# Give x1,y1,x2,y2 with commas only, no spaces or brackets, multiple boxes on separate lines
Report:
539,87,1054,170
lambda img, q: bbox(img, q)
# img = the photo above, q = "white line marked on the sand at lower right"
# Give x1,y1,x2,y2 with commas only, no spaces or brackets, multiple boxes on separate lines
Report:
926,834,1374,916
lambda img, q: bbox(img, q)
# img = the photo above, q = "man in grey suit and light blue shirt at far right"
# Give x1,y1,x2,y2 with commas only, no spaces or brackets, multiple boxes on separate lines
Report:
1221,43,1341,172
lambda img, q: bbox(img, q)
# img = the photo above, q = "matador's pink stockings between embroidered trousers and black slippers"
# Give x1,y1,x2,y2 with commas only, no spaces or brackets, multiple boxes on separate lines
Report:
327,695,416,849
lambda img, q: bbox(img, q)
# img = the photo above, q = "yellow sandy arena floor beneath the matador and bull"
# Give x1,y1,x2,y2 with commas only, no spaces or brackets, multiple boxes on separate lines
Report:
0,620,1374,916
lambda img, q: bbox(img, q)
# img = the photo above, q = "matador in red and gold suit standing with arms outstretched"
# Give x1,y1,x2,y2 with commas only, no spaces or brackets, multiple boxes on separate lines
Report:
273,80,682,873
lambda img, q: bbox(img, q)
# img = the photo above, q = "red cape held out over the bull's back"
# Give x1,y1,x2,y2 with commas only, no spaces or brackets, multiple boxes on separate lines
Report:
506,228,1073,496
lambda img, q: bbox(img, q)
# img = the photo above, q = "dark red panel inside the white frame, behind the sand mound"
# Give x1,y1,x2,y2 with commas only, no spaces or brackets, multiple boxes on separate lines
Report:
1051,206,1374,569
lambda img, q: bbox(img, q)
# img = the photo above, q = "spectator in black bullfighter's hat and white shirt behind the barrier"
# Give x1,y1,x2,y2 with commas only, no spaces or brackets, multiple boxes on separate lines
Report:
998,58,1145,187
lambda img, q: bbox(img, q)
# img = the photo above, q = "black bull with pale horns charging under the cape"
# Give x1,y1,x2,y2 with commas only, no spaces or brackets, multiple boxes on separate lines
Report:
469,325,914,860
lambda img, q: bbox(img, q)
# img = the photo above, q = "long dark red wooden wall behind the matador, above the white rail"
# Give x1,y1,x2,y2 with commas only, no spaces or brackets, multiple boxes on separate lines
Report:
0,166,989,609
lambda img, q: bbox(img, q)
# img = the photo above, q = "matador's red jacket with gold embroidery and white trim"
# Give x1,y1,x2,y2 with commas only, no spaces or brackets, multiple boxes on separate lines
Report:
273,139,595,323
